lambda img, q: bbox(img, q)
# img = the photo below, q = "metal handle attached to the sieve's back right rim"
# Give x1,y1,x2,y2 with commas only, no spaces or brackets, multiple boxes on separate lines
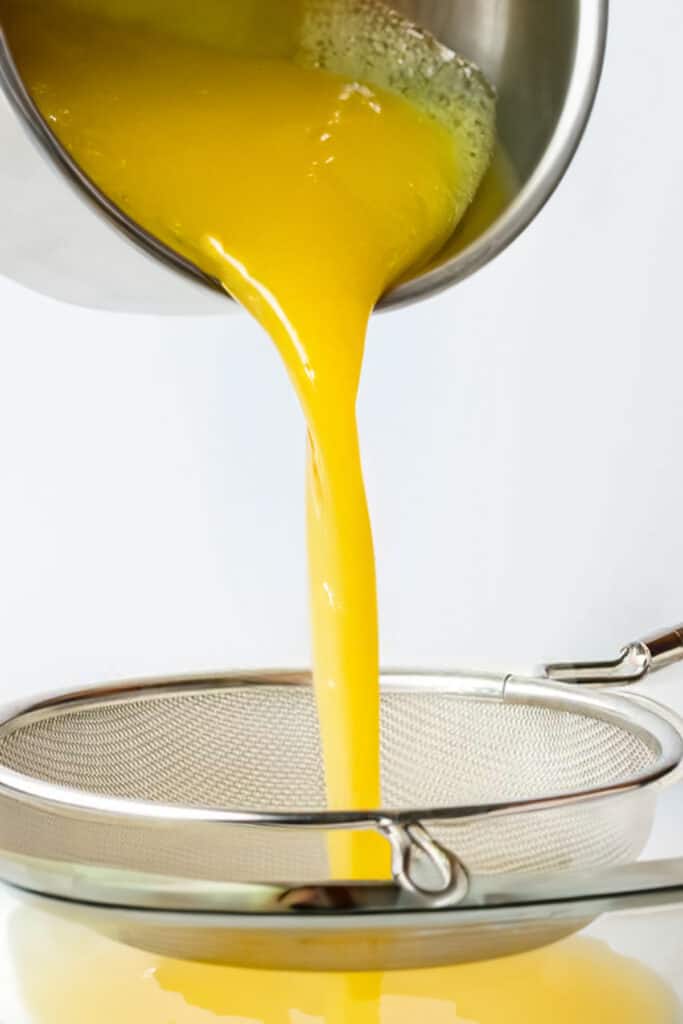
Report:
544,625,683,686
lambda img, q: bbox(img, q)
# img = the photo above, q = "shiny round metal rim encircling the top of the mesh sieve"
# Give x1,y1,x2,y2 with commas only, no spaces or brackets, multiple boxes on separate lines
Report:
0,669,683,831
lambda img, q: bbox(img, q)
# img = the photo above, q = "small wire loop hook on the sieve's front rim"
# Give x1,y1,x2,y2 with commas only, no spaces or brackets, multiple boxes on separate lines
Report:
382,821,469,909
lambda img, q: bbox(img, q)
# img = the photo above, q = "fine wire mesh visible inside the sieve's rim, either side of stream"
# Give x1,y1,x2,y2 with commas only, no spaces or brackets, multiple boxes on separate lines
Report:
0,685,657,811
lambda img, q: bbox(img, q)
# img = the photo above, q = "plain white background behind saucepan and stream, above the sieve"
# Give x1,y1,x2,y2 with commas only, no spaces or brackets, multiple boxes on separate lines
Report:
0,0,683,697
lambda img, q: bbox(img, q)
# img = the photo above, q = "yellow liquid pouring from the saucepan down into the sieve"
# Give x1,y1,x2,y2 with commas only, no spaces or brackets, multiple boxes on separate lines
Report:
0,0,499,878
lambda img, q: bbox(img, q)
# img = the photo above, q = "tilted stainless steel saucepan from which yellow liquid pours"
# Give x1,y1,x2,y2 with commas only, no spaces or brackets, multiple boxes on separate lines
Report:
0,0,607,313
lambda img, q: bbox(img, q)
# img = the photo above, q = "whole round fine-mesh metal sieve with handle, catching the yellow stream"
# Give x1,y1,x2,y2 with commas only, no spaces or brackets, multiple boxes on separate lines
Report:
0,618,683,970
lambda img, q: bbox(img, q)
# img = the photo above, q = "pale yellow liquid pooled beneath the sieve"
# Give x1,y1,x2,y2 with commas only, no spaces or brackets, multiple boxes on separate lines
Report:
9,910,683,1024
